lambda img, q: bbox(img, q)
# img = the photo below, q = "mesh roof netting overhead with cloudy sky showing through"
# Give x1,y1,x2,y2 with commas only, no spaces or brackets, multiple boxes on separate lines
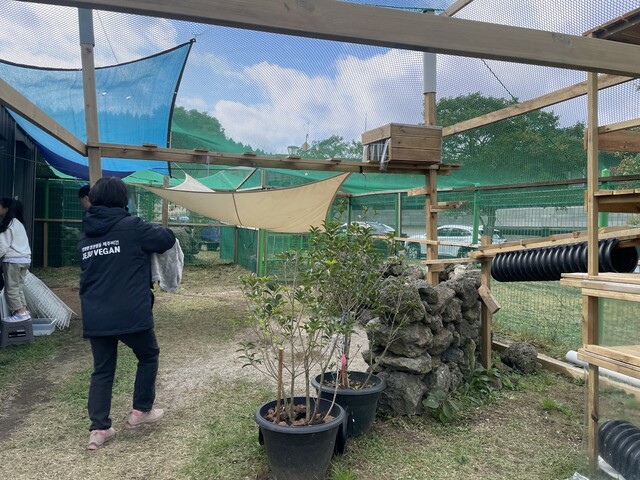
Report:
0,0,640,193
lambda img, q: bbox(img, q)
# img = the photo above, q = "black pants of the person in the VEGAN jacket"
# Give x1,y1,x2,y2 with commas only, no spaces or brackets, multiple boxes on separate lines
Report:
88,328,160,430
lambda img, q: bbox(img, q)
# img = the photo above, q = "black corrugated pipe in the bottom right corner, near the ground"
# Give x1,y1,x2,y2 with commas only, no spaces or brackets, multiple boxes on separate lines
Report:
598,420,640,480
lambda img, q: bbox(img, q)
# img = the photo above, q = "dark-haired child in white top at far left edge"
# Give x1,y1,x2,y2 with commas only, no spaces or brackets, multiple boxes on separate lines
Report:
0,198,31,322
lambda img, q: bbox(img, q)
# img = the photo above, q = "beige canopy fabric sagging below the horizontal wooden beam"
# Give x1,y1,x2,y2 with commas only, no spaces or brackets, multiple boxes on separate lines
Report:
139,173,349,233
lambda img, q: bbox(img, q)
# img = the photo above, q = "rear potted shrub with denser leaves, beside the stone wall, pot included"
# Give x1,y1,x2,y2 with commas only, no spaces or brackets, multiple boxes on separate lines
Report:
307,222,386,435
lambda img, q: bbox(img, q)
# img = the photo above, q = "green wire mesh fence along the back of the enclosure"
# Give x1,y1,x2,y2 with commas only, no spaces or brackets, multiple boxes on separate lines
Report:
34,171,640,362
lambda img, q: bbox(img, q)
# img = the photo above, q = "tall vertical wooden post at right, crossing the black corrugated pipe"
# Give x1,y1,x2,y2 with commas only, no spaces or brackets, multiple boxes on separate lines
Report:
582,65,600,472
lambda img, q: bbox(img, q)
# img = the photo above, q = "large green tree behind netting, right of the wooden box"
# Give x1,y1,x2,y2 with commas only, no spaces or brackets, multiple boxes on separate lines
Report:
437,93,586,185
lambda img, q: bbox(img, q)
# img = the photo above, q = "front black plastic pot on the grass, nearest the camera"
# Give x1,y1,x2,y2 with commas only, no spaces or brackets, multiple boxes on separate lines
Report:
254,397,347,480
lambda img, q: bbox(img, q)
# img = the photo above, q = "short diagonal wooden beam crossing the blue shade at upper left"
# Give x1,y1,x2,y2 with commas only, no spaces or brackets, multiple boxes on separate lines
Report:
0,78,87,157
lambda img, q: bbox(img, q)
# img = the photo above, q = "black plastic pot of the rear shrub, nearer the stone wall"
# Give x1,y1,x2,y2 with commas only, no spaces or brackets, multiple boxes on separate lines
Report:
311,372,387,436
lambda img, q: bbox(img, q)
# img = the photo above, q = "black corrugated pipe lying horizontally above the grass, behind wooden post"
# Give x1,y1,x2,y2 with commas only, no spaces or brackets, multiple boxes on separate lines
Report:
491,238,638,282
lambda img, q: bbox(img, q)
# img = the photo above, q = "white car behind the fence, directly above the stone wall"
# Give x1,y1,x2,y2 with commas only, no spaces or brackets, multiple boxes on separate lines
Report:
404,225,506,259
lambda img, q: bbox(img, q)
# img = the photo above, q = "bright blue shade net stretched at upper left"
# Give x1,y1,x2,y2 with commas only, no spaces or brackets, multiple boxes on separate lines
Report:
0,42,192,179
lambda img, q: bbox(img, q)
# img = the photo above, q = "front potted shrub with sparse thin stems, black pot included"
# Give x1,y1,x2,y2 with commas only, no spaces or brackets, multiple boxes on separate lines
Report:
241,252,347,480
